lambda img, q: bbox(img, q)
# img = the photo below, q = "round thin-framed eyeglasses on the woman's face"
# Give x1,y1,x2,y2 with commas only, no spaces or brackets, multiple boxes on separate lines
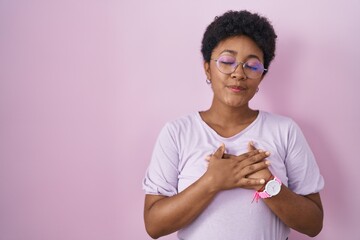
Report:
211,56,267,79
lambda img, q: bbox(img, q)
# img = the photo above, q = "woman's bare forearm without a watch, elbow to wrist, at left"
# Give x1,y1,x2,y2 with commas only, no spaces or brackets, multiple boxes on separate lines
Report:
145,176,216,238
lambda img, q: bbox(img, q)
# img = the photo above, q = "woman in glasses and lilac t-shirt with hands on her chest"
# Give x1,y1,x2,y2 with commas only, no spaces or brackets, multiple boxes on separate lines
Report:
143,11,324,240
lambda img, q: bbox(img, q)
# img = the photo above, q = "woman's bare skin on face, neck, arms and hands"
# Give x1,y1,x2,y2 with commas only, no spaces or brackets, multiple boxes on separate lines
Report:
144,36,323,238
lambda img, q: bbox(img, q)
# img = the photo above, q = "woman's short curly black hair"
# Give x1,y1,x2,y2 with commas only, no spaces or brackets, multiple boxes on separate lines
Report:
201,10,277,68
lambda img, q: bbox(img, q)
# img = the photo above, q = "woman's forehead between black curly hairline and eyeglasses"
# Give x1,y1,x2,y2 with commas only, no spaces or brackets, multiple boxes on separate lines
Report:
212,36,264,61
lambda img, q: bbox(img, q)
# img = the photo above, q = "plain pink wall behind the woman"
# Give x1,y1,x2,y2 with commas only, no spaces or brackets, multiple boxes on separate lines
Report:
0,0,360,240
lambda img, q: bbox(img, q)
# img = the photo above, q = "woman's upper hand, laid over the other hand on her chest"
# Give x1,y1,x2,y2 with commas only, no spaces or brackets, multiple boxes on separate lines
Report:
204,144,269,191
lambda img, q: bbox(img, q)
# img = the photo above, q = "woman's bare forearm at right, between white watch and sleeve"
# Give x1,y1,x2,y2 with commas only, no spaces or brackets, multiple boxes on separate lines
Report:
263,185,323,237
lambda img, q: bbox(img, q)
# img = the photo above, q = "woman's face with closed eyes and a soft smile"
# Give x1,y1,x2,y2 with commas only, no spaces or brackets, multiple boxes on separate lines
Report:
204,36,264,107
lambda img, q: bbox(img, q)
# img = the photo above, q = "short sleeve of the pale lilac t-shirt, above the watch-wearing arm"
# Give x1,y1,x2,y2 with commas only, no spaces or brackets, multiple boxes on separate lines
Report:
285,122,324,195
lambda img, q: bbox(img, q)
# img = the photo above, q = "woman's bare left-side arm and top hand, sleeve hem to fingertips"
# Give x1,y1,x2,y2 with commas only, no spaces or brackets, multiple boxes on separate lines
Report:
144,146,268,238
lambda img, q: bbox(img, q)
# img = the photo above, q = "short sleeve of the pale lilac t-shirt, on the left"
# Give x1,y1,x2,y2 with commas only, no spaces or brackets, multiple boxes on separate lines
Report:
143,123,179,197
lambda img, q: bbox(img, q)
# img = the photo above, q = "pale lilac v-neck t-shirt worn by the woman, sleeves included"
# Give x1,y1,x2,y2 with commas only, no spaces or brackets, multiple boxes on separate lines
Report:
143,111,324,240
